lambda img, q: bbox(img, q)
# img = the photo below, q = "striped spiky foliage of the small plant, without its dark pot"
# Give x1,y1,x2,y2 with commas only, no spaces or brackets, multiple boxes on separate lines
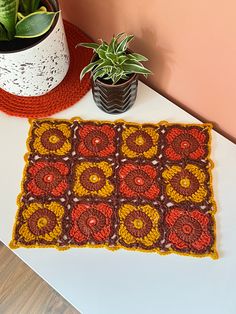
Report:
78,33,152,84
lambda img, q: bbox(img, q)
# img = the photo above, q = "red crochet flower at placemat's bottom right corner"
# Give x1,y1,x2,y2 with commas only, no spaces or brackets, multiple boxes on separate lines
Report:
165,208,212,252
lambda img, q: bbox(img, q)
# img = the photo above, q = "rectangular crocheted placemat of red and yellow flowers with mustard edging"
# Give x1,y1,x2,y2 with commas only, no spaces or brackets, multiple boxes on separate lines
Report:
10,118,217,258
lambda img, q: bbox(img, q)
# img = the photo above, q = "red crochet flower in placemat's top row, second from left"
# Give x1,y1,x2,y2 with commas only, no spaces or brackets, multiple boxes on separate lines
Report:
77,124,115,157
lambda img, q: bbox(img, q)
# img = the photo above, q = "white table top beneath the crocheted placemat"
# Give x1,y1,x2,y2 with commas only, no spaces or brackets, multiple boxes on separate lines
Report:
0,83,236,314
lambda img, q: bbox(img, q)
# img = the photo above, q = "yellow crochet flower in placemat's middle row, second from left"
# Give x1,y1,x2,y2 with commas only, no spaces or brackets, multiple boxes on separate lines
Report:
74,161,114,197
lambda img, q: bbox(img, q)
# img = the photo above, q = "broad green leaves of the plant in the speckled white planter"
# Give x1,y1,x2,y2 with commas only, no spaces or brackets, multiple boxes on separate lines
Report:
0,0,58,41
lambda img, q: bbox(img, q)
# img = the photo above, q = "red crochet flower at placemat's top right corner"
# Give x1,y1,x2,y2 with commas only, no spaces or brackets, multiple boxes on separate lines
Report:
165,127,207,161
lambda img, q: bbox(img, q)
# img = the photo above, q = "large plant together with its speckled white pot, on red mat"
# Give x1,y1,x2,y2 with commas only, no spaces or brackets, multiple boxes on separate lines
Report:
0,0,69,96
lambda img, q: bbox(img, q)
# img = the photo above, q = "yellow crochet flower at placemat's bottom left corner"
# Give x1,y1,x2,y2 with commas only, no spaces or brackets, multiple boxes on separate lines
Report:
19,202,64,242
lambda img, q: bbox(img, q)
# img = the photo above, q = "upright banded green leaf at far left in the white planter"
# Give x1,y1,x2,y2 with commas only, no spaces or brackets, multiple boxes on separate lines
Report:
0,0,19,40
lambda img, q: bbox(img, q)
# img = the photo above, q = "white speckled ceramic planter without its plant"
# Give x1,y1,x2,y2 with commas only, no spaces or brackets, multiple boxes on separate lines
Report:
0,13,70,96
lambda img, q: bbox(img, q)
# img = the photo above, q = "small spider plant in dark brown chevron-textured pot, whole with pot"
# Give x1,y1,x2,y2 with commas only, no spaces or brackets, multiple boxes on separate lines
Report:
79,33,151,114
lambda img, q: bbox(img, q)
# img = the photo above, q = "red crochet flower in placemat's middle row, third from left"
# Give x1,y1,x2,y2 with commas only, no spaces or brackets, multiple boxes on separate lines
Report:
119,164,160,199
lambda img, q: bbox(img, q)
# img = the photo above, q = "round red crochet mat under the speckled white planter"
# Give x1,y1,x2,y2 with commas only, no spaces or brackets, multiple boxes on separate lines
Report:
0,21,92,118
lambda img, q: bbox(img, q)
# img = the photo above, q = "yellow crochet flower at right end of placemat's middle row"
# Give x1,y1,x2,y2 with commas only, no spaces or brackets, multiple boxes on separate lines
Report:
162,164,207,203
